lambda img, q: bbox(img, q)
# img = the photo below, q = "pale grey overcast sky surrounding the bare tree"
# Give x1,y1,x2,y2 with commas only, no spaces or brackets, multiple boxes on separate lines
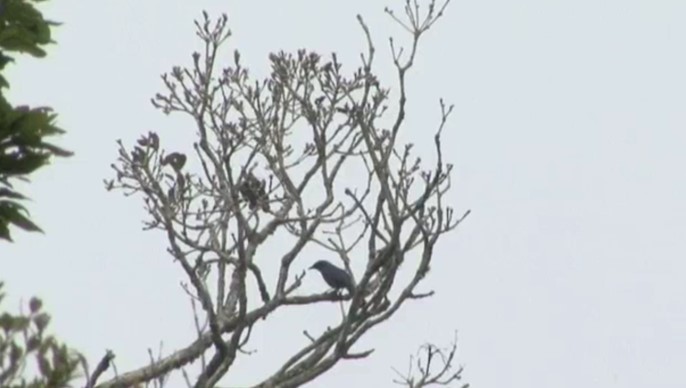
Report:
5,0,686,388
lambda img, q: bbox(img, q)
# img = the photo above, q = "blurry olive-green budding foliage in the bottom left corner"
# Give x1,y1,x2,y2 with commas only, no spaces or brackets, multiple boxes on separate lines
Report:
0,282,85,388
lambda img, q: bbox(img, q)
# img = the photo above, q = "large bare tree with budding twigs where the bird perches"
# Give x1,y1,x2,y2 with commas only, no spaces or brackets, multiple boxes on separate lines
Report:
98,0,469,388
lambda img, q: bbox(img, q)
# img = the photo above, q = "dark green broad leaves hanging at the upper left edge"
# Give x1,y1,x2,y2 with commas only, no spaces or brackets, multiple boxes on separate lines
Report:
0,0,71,241
